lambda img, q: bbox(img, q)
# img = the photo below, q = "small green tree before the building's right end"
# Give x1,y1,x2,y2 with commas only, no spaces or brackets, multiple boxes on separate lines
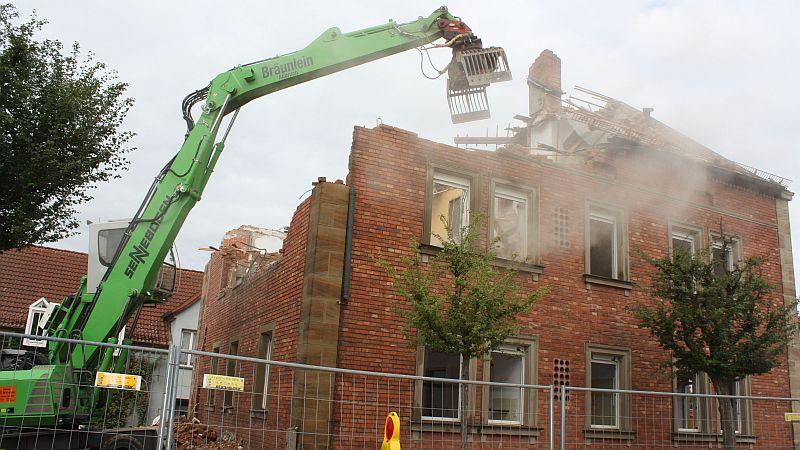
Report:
632,229,798,450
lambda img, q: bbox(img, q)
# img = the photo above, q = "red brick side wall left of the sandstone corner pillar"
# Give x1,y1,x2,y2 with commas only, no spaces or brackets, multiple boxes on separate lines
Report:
193,198,310,448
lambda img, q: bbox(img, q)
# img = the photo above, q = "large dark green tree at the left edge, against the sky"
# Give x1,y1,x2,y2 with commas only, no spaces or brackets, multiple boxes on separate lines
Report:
0,4,133,252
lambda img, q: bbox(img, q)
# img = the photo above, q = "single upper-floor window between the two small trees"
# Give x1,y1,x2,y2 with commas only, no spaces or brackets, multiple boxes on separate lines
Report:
586,206,626,280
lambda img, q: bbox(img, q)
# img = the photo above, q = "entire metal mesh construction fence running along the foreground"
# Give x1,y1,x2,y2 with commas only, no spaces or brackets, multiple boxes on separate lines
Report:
0,332,800,450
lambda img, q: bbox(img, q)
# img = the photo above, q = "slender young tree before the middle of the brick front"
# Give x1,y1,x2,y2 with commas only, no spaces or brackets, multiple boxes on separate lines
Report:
383,215,546,449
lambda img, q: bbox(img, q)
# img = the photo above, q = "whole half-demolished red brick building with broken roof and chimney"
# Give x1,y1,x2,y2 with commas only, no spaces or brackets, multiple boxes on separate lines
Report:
196,51,800,448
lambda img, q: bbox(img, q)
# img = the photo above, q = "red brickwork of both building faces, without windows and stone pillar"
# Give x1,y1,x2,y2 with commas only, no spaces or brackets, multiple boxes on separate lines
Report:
191,121,791,448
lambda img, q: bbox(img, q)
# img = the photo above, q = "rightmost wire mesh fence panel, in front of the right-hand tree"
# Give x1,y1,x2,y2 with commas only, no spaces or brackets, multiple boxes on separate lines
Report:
561,387,800,449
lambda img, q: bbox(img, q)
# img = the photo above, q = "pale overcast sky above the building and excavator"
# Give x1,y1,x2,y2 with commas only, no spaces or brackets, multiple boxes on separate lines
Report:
16,0,800,288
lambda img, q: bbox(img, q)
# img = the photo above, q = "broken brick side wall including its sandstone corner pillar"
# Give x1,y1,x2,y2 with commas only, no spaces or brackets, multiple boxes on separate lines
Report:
195,180,350,448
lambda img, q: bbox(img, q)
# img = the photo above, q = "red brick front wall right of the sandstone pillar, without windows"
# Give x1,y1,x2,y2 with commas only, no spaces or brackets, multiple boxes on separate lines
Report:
334,125,790,445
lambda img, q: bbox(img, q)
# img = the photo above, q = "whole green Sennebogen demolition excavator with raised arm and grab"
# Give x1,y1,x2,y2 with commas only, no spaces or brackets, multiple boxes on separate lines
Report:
0,7,511,448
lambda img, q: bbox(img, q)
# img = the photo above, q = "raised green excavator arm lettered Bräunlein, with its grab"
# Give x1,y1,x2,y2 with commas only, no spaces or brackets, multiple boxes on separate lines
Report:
0,7,510,426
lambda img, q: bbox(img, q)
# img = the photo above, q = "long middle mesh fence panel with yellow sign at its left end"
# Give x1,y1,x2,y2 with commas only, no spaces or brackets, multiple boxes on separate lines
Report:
175,351,552,449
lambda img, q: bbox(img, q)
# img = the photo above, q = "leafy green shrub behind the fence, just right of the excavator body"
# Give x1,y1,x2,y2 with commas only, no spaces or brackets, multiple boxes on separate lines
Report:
91,355,155,428
